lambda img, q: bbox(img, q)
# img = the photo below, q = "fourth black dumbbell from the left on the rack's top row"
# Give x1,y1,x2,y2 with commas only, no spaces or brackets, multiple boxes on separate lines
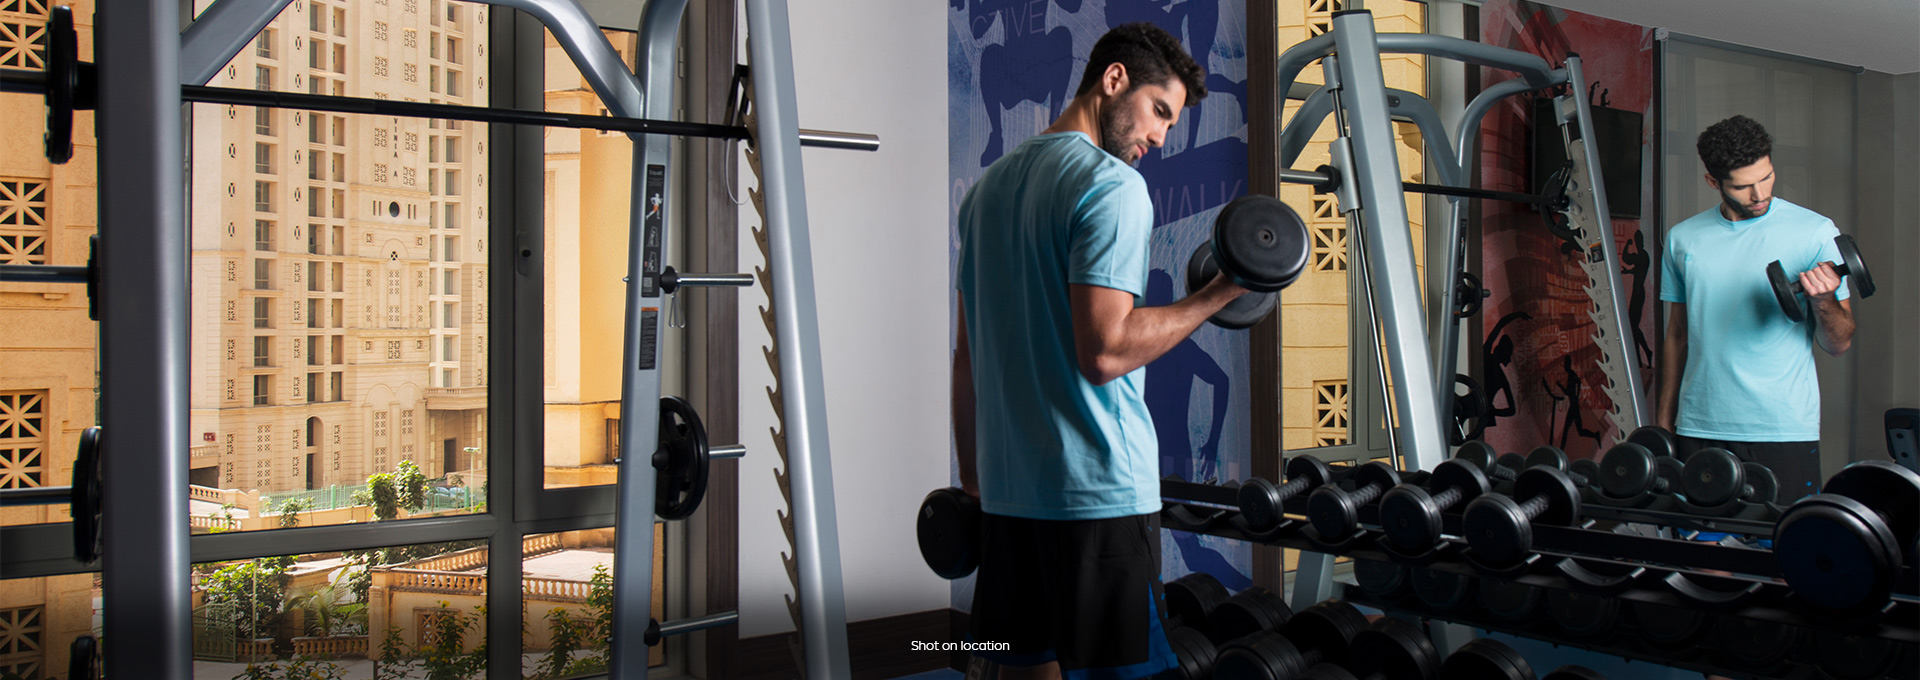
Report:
1463,467,1580,567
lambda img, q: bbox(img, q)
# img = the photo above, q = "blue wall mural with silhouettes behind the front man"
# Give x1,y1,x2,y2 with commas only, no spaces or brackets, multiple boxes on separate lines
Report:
947,0,1252,609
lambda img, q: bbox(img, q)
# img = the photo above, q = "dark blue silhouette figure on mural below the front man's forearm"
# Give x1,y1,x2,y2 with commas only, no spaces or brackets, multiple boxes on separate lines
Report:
1144,269,1254,592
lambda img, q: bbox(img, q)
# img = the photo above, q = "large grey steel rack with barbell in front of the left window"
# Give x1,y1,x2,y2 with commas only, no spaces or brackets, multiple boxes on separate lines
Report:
6,0,856,680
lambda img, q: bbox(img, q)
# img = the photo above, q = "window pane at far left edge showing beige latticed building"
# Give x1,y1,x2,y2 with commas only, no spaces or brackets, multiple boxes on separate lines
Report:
0,2,100,530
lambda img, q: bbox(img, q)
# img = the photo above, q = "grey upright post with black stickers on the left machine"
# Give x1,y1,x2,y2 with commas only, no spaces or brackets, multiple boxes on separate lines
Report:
593,0,687,680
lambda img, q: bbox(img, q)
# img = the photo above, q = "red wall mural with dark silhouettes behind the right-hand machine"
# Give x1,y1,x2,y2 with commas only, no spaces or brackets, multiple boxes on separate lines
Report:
1476,0,1661,459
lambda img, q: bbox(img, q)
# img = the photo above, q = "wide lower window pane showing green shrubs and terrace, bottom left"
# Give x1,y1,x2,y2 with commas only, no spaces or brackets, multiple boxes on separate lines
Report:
194,540,488,680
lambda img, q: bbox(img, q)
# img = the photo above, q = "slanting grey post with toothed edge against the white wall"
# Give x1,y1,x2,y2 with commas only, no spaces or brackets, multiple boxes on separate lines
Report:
747,0,852,680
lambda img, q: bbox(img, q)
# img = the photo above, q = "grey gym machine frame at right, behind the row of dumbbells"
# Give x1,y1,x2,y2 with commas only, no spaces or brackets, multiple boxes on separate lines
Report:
1275,10,1649,601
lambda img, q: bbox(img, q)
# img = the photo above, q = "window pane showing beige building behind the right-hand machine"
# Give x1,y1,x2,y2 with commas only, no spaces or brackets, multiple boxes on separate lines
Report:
1277,0,1427,451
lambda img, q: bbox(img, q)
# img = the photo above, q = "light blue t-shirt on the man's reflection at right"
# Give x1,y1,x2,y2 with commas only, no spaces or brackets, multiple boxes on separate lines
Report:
1661,196,1847,442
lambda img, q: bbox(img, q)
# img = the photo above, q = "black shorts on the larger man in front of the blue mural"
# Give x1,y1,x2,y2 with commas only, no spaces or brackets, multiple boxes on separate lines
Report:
968,513,1177,680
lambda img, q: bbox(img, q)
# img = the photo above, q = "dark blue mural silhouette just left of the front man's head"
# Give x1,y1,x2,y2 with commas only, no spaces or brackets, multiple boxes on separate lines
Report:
948,0,1081,167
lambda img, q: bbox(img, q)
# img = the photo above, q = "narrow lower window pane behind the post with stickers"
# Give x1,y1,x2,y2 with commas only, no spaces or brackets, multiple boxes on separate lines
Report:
520,522,668,678
